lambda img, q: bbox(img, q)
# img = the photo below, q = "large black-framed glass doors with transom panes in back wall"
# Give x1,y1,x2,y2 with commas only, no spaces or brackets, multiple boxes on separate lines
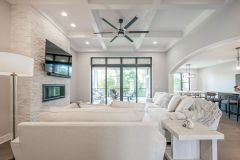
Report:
91,57,152,104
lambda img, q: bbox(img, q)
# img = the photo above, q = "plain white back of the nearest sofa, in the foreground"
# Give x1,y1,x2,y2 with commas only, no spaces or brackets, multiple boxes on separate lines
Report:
11,122,166,160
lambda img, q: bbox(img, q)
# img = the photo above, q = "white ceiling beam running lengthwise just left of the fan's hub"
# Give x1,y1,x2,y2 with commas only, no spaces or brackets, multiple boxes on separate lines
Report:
83,0,107,50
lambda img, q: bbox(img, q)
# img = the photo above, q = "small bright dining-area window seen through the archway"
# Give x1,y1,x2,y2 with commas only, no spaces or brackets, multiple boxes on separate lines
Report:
173,73,191,91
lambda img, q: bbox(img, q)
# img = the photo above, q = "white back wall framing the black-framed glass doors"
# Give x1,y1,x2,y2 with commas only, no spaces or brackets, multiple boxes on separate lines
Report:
74,53,168,101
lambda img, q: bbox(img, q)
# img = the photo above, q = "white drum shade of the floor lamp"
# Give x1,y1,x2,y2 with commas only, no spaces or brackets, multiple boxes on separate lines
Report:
0,52,34,77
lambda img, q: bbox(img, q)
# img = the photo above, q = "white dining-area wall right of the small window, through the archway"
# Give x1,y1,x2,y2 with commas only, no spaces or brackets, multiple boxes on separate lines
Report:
198,62,237,92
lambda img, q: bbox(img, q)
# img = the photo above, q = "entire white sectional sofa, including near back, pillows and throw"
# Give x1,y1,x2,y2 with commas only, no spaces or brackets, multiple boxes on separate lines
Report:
12,92,222,160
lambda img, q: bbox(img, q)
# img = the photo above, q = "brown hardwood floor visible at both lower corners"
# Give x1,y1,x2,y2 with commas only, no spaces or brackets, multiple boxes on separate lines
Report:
0,115,240,160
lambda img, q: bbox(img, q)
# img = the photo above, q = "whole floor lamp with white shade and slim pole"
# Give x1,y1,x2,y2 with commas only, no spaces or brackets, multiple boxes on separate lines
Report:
0,52,34,139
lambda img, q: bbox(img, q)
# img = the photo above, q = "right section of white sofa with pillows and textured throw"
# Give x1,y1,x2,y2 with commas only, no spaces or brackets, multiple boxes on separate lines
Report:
146,92,222,131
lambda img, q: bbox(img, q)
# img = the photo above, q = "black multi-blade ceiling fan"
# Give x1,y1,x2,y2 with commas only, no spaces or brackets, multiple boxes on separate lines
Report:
94,16,149,42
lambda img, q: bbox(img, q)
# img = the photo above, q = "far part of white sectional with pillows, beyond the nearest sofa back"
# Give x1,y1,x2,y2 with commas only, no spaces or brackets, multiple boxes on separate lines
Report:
39,92,222,139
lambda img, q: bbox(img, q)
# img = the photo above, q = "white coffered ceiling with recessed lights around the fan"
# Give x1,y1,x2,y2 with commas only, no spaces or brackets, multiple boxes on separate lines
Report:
8,0,227,52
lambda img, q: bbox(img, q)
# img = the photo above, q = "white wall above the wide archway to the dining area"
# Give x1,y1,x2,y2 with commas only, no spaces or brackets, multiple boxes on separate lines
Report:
167,0,240,92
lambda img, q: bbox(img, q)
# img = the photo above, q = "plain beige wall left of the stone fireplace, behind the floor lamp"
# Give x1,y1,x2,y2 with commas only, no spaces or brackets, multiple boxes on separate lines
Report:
0,0,11,143
